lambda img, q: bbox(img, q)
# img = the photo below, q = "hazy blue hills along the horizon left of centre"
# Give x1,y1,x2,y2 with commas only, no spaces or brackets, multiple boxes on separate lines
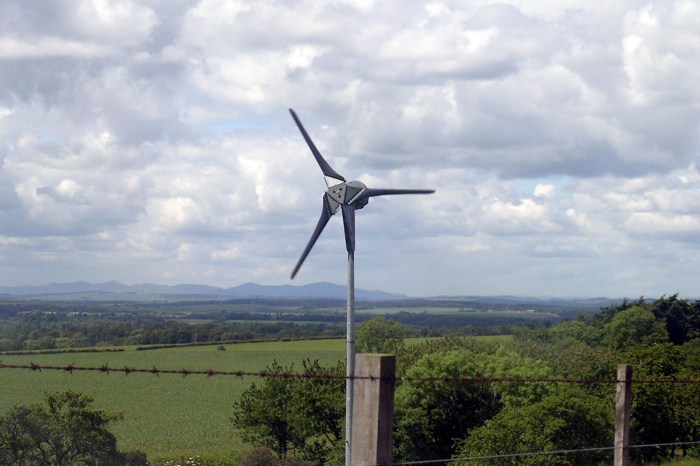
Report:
0,281,408,301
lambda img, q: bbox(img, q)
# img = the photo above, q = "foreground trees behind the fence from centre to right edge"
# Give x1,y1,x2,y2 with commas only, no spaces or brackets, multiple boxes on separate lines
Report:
232,295,700,465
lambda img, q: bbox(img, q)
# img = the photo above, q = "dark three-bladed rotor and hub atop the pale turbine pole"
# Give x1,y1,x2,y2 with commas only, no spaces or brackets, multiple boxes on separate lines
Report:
289,108,435,278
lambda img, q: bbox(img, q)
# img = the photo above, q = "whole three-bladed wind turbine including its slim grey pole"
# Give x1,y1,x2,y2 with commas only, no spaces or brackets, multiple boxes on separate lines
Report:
289,108,435,466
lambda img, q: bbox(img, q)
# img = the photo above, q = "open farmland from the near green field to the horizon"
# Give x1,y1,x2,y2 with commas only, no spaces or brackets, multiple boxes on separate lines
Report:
0,299,608,463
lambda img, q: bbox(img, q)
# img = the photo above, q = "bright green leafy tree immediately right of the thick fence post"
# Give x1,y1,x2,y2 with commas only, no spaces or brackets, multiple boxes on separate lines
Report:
395,349,550,461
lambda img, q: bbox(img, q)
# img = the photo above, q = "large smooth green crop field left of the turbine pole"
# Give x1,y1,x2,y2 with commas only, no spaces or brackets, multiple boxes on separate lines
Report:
0,340,345,460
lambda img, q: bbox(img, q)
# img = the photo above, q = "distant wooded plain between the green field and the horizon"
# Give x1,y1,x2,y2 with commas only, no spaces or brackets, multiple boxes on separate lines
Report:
0,298,586,352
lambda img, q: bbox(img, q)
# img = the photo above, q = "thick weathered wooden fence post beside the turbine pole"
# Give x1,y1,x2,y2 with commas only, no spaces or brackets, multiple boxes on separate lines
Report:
351,354,396,466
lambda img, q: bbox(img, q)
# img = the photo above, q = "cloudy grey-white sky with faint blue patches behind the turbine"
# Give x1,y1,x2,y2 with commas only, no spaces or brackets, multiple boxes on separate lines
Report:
0,0,700,298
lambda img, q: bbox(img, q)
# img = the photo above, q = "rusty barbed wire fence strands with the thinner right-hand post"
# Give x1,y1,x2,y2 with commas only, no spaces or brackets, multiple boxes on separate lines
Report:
0,360,700,466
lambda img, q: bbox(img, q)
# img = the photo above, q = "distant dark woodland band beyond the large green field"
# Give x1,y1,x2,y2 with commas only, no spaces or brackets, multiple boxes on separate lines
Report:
0,309,551,352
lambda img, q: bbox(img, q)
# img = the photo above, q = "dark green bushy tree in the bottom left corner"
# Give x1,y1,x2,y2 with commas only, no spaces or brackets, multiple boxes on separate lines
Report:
0,391,127,466
